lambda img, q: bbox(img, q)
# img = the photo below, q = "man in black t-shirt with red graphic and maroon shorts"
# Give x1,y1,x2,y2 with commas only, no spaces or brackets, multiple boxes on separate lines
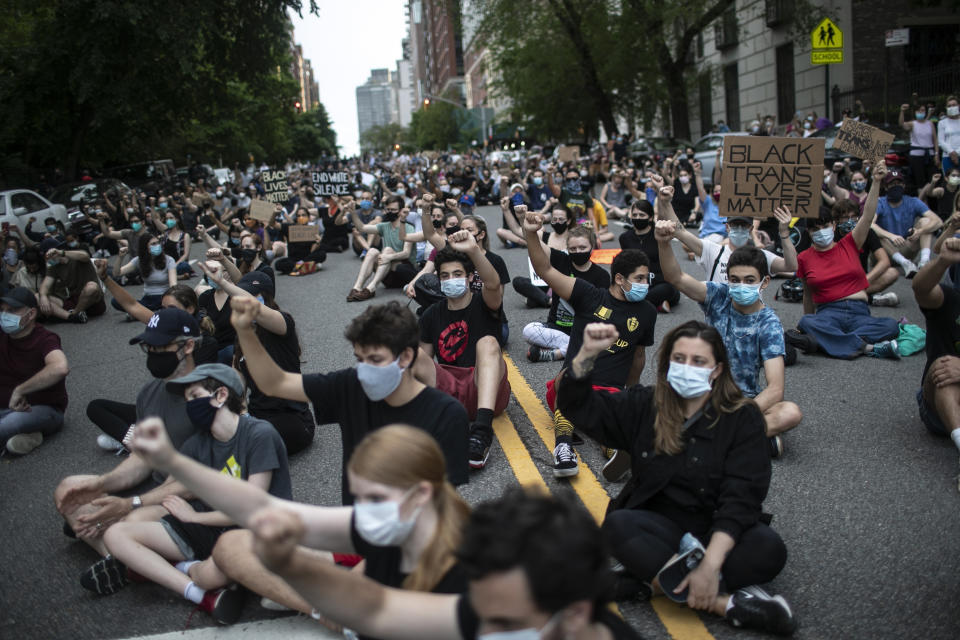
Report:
414,230,510,469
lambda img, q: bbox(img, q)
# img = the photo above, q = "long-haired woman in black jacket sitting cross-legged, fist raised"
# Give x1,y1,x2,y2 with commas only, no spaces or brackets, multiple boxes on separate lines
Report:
557,320,796,635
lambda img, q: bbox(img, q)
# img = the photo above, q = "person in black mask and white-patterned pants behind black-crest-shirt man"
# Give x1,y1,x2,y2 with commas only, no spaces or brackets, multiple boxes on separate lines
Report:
514,227,610,362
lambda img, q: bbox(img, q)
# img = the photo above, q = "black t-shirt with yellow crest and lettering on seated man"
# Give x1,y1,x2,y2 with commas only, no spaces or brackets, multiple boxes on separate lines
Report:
567,279,657,387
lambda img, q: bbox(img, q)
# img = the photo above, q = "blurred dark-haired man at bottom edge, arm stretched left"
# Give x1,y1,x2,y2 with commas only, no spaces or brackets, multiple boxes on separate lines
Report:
244,488,639,640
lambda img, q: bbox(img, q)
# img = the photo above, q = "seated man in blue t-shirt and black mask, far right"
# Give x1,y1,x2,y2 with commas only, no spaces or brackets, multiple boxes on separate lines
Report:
864,168,943,278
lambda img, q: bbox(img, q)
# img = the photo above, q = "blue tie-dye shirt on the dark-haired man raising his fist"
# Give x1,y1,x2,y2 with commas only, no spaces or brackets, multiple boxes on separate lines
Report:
700,282,784,398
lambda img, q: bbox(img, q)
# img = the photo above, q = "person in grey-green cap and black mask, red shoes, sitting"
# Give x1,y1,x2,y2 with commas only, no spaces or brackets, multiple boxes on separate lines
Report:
80,364,292,624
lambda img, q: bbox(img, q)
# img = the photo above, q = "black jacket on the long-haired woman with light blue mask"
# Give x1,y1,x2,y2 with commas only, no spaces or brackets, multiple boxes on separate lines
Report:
557,369,771,541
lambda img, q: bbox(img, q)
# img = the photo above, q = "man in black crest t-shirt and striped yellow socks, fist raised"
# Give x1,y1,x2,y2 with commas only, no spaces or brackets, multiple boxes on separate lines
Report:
523,212,657,481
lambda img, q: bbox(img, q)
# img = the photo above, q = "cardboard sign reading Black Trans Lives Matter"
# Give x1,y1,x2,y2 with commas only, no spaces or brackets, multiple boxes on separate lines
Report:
720,136,824,218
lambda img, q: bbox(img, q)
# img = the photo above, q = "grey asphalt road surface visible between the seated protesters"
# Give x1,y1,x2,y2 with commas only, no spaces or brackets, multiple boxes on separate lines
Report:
0,207,960,640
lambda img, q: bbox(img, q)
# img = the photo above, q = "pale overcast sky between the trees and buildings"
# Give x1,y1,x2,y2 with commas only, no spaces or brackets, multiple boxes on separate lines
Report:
291,0,407,156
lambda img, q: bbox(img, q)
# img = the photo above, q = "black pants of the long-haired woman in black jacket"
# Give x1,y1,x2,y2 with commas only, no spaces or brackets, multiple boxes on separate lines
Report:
602,509,787,593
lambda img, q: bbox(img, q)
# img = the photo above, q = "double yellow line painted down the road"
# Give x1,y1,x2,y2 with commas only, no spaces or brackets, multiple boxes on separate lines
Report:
493,354,713,640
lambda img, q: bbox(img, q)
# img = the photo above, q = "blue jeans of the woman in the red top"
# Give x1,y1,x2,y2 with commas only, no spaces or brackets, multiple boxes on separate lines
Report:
797,300,900,359
